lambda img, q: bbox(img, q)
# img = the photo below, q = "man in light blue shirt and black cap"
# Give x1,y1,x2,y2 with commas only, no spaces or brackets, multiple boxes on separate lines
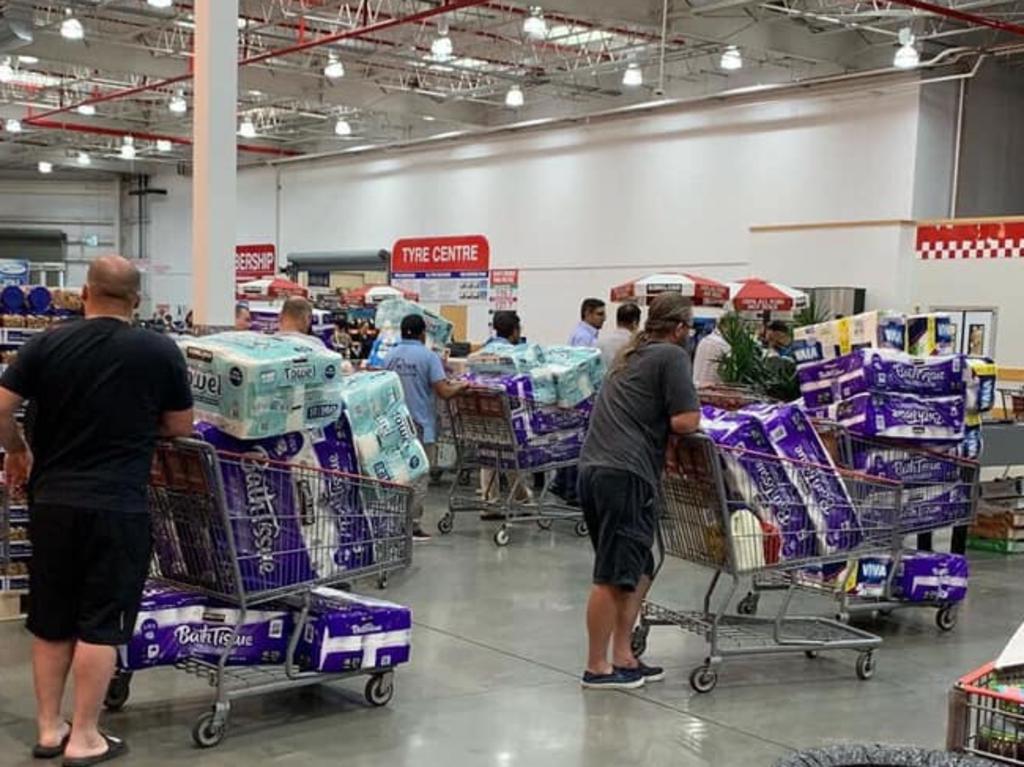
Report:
387,314,467,542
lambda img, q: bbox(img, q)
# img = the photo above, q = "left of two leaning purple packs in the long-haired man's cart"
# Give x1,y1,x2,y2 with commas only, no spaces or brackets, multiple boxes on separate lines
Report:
700,406,815,560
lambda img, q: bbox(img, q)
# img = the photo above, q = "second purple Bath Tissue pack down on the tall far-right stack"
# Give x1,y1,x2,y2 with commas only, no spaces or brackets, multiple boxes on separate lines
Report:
837,391,965,441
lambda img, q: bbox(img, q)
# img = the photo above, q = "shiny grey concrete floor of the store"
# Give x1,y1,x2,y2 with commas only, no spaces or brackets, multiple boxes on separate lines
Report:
0,497,1024,767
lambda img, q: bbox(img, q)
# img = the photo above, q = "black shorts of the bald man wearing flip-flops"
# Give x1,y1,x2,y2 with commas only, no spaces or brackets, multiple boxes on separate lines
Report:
27,504,153,645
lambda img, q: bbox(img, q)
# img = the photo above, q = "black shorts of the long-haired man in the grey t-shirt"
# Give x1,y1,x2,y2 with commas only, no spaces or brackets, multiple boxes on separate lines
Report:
579,466,657,591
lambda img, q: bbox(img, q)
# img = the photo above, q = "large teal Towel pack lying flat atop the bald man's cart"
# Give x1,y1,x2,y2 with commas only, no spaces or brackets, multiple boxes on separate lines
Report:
179,331,342,439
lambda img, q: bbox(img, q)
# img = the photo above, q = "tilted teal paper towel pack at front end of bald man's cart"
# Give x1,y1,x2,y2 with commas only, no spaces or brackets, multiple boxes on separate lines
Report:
341,371,430,484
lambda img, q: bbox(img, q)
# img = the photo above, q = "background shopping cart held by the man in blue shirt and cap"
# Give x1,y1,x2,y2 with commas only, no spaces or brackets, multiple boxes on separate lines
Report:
437,387,587,546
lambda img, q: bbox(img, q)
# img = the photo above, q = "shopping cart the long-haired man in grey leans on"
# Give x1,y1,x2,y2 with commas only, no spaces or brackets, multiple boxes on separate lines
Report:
633,435,900,692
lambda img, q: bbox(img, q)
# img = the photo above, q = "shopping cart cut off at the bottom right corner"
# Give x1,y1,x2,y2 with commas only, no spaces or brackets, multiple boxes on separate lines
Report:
946,664,1024,765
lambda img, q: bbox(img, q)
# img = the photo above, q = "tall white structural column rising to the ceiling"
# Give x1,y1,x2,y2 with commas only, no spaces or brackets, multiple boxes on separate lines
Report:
193,0,239,326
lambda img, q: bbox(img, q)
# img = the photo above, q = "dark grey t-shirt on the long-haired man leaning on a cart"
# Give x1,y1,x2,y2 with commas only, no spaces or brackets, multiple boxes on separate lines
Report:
580,342,700,487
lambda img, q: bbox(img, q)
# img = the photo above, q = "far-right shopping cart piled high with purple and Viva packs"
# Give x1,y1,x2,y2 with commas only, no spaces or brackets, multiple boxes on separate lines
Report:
737,424,981,631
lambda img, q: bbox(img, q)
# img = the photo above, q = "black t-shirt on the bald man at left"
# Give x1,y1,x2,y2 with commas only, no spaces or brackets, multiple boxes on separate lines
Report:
0,317,193,512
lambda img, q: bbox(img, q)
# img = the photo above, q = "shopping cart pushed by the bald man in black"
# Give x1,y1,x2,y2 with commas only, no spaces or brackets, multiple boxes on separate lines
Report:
105,440,413,748
